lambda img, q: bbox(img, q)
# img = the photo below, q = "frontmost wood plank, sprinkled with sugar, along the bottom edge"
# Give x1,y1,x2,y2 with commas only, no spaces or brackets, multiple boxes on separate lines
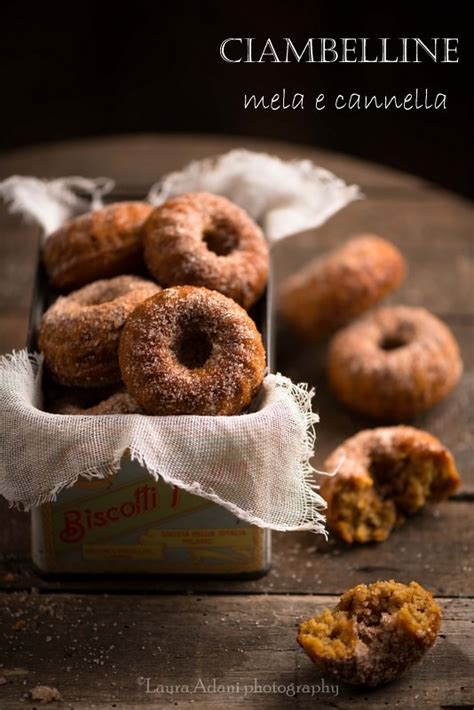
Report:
0,594,474,710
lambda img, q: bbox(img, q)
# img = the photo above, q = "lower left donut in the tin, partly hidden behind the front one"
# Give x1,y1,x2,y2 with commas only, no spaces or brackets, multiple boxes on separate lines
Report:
39,276,160,387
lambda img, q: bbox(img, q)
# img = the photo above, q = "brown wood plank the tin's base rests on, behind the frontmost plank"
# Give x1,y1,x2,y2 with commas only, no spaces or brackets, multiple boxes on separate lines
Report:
0,500,474,596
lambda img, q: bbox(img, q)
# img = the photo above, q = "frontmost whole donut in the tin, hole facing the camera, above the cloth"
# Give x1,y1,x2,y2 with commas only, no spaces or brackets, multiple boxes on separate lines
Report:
119,286,265,415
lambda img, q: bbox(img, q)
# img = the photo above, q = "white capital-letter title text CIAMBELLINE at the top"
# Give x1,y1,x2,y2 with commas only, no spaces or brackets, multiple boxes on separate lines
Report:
220,37,459,64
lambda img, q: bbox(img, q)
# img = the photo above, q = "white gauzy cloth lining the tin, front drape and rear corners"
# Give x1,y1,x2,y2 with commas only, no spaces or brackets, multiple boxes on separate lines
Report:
0,150,361,534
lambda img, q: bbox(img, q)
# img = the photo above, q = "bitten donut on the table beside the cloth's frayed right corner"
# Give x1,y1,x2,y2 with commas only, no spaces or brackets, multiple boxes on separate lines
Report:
321,426,460,543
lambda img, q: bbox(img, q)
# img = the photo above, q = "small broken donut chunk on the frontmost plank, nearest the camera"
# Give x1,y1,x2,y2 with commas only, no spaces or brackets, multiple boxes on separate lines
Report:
297,580,441,687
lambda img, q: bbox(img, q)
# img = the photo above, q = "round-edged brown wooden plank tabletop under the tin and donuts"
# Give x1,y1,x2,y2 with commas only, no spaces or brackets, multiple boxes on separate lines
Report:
0,135,474,710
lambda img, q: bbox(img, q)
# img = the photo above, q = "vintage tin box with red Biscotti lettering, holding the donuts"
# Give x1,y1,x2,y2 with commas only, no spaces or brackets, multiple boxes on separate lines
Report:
28,209,273,578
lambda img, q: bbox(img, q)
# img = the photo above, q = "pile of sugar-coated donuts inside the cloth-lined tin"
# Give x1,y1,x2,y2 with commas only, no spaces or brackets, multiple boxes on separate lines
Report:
38,193,269,415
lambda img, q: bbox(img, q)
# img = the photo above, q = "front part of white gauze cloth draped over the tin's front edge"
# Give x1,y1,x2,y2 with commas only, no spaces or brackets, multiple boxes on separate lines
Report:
0,350,325,532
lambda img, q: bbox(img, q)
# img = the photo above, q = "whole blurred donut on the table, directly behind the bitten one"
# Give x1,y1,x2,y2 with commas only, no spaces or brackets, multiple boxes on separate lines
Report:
328,306,462,421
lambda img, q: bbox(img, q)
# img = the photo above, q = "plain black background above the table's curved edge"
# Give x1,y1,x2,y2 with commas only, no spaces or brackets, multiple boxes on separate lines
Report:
0,0,473,195
